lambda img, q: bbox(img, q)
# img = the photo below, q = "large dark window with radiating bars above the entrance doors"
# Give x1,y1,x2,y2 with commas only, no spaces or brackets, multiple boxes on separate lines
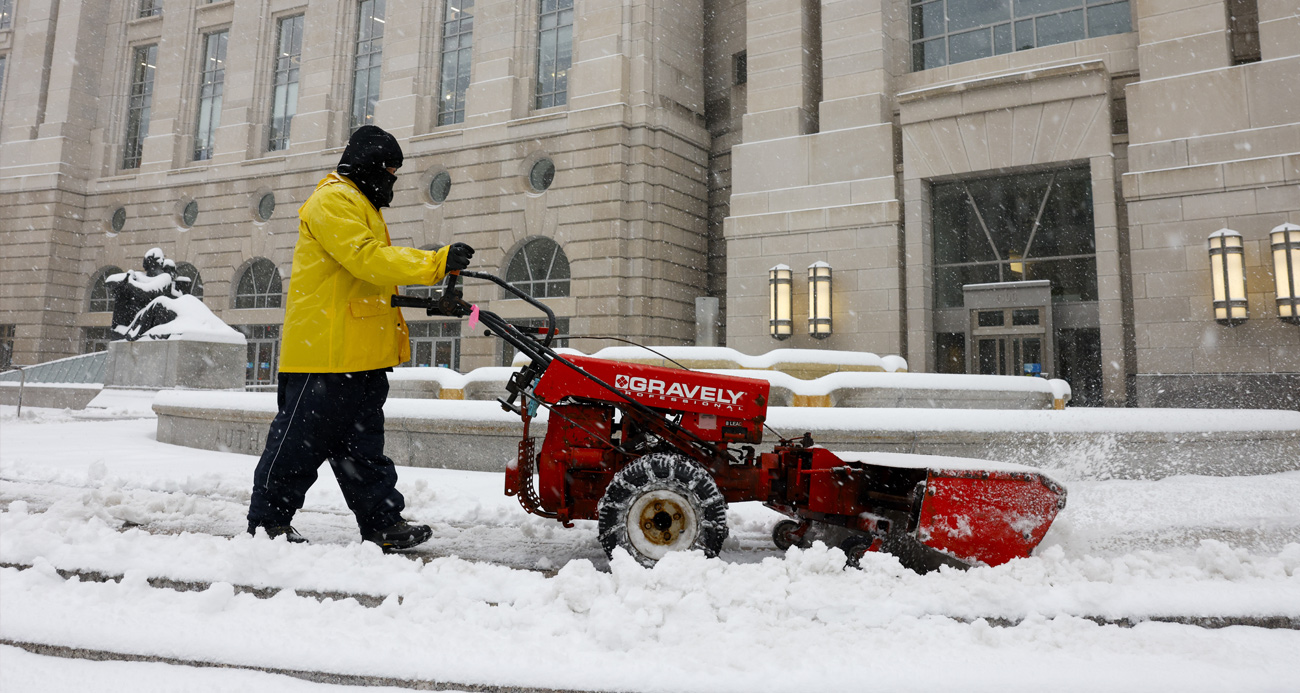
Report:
931,168,1097,308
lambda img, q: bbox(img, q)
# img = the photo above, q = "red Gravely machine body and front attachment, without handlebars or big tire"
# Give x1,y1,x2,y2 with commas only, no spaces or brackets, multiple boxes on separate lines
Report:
506,356,1065,569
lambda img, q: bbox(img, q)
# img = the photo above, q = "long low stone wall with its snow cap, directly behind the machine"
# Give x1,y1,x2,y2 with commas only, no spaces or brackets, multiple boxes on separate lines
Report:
153,390,1300,481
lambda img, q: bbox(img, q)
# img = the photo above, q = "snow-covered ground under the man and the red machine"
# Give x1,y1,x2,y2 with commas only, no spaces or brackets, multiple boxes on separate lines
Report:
0,407,1300,693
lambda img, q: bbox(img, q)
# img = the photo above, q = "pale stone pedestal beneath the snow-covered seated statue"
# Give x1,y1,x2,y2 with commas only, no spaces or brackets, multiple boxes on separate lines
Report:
104,339,247,390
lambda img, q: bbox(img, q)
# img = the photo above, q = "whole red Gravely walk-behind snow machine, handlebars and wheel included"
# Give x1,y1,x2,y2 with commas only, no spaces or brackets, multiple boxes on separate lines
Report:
393,270,1066,572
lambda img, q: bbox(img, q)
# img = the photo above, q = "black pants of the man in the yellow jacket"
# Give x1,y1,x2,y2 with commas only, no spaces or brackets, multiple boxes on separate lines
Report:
248,371,406,536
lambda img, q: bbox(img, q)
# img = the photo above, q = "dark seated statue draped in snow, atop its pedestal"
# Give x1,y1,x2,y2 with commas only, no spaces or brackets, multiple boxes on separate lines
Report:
104,248,238,342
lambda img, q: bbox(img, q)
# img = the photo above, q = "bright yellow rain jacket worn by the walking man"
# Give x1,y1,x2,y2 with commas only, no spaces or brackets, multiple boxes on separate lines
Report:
280,173,447,373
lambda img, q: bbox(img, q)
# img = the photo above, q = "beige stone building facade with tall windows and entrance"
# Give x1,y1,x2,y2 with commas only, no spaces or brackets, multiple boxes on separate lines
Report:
0,0,1300,407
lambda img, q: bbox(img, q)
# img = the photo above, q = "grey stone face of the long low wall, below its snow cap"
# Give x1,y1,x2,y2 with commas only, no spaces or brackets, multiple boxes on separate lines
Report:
153,395,1300,480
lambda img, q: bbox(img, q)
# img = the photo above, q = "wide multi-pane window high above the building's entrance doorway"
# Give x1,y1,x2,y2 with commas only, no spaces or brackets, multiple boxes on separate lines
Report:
911,0,1132,70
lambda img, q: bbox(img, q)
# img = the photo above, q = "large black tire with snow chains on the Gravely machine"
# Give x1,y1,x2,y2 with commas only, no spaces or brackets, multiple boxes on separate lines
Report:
597,452,727,567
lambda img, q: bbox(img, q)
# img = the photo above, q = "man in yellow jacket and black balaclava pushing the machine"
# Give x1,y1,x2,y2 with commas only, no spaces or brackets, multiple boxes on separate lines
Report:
248,125,475,551
